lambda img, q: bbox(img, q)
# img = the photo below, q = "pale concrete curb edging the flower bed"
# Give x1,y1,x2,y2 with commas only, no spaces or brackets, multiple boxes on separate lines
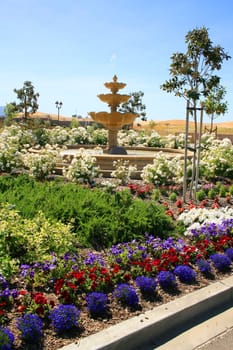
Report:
60,276,233,350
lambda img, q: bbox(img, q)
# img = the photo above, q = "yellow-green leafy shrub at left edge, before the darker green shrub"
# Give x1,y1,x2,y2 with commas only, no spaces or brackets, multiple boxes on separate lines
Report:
0,203,77,276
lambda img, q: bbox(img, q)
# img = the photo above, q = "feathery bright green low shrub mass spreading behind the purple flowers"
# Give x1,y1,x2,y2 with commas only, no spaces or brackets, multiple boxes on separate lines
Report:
0,175,173,249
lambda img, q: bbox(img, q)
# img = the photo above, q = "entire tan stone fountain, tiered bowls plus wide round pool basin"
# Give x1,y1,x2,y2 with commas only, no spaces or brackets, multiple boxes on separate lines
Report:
58,75,189,179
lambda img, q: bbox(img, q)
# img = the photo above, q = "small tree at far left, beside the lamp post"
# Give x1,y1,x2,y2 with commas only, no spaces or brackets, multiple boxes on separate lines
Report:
12,81,40,120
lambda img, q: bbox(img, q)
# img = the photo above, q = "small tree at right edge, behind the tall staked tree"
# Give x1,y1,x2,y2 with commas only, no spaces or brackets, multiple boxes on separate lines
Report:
203,85,228,132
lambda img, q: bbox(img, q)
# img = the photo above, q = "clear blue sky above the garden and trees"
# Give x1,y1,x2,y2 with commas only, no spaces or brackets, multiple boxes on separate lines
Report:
0,0,233,122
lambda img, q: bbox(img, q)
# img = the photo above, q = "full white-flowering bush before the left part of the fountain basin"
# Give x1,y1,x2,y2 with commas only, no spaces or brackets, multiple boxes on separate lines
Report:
63,149,100,184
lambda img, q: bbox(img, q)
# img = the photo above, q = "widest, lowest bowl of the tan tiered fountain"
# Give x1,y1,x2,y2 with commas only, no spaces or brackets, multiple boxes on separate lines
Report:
88,112,138,130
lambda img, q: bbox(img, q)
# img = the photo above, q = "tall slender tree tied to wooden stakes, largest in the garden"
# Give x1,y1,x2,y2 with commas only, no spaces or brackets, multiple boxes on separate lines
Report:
161,27,231,197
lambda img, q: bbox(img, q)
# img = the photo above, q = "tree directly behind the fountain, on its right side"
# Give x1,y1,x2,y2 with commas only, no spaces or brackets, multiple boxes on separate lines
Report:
118,91,146,121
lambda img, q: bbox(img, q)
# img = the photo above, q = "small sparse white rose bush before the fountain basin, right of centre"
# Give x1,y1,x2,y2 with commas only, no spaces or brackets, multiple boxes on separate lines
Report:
111,159,137,185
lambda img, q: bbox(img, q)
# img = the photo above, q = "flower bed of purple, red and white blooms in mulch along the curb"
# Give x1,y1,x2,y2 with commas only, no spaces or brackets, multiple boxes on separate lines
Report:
0,178,233,350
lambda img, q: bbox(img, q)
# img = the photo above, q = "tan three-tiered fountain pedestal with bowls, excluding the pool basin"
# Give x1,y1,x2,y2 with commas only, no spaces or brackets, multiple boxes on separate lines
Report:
89,75,138,154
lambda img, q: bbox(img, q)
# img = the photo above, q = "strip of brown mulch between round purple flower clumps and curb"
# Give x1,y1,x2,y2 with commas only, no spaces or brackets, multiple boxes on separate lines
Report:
8,270,233,350
